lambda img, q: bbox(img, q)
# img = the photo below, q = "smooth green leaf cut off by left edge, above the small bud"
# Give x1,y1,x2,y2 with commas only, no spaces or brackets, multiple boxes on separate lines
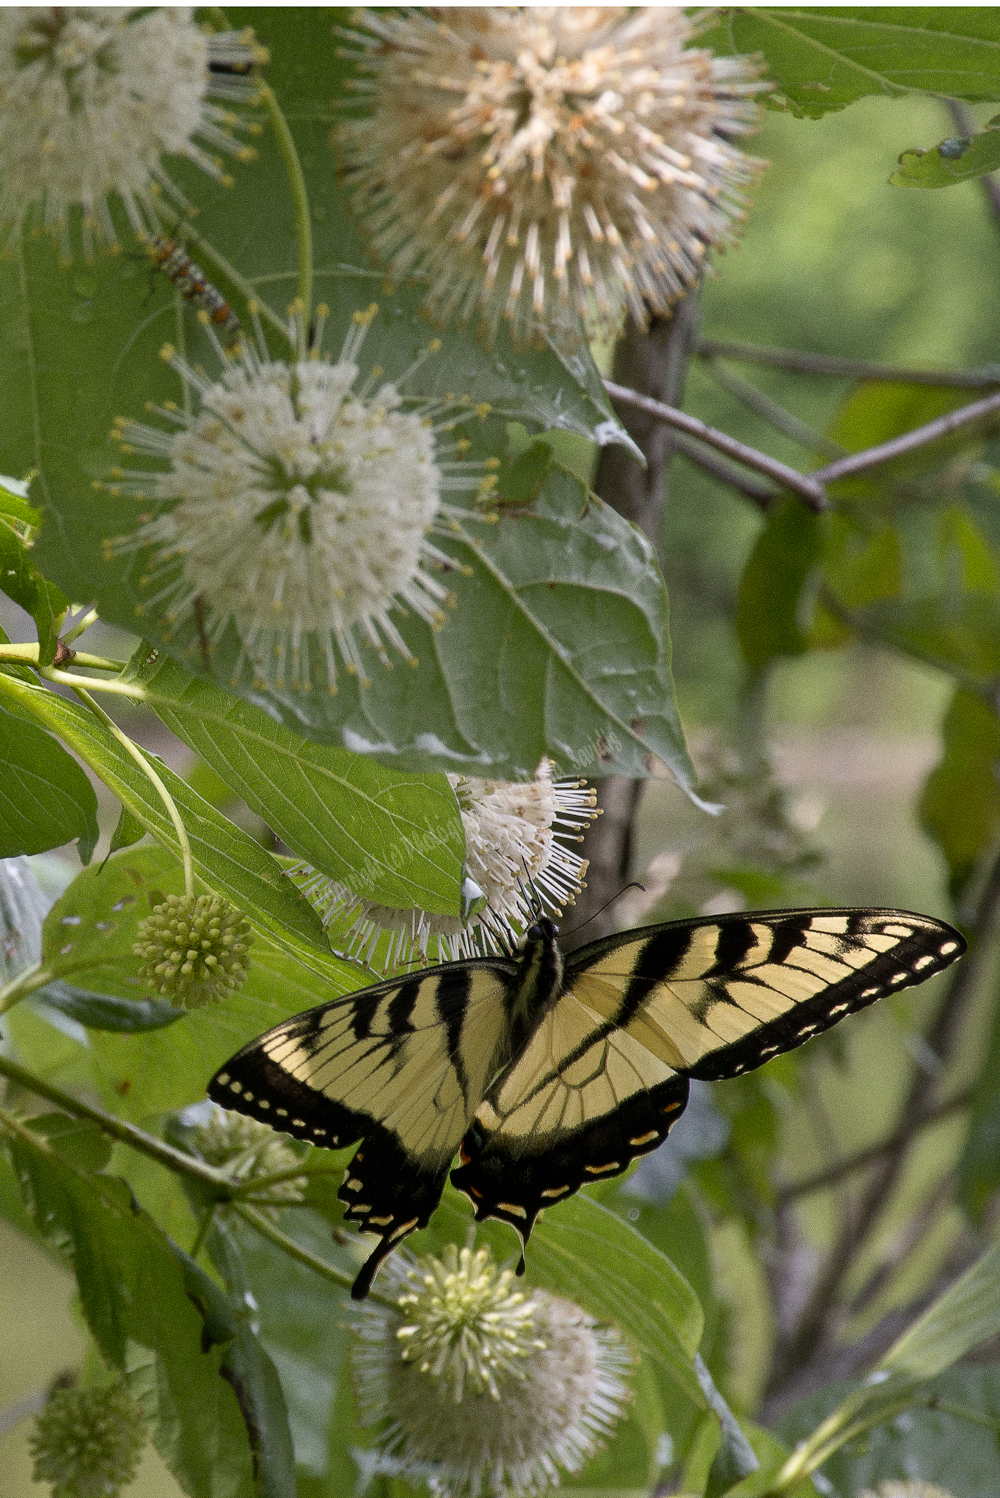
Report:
0,695,99,863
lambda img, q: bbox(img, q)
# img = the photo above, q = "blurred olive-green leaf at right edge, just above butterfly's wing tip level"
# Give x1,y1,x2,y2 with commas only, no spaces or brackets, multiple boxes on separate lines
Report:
919,688,1000,896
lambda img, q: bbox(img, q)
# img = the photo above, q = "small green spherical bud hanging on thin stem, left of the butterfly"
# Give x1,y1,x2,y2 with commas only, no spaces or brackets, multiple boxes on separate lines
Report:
132,894,253,1010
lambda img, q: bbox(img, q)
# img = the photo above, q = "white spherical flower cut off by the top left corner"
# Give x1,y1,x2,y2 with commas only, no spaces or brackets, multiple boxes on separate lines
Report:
0,6,266,258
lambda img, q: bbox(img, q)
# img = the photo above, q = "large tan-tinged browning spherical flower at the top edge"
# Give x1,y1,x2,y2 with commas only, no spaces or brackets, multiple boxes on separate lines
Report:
338,6,766,343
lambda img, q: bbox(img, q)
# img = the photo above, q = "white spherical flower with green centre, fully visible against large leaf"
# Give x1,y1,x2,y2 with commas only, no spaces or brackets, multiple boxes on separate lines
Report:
97,306,496,691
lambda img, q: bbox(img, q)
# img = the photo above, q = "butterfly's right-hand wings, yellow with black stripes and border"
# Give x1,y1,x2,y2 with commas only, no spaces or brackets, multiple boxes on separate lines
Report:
452,911,966,1243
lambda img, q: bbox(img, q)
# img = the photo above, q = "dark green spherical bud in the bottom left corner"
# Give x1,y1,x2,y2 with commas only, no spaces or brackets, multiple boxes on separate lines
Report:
30,1384,147,1498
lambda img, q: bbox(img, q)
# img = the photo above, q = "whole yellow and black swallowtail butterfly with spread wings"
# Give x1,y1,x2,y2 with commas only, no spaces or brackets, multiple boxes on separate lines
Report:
208,909,966,1300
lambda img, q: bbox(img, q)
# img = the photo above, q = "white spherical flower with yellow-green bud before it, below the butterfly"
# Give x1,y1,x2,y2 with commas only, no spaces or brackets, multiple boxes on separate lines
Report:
352,1245,630,1498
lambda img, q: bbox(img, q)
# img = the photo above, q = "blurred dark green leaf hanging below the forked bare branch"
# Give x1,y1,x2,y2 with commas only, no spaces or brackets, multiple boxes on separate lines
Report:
737,499,822,670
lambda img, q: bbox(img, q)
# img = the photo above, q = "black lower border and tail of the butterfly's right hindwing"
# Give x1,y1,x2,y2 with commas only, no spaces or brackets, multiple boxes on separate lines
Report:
451,1076,689,1275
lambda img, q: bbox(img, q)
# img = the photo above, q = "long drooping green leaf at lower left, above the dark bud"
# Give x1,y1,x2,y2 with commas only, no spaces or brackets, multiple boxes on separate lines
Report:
12,1140,264,1498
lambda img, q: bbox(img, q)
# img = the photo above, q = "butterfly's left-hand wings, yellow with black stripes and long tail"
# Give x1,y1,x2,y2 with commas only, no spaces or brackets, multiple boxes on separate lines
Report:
208,959,516,1299
